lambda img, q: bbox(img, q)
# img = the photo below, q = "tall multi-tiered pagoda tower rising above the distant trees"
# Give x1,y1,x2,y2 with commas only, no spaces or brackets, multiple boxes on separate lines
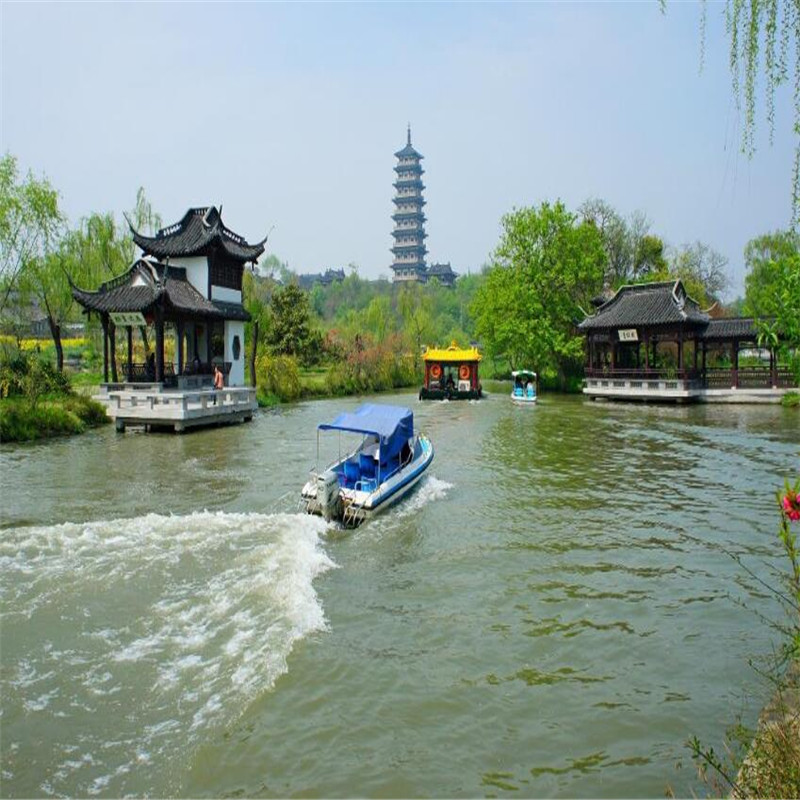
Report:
392,125,428,283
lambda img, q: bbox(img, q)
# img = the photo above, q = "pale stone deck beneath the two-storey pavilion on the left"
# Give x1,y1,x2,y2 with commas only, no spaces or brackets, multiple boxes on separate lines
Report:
94,383,258,433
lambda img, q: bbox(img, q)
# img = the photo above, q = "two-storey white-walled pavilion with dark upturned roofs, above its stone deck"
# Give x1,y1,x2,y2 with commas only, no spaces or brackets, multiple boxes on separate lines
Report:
73,206,266,388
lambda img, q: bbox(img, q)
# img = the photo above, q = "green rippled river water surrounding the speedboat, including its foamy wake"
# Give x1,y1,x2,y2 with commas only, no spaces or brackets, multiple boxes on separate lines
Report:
0,385,800,797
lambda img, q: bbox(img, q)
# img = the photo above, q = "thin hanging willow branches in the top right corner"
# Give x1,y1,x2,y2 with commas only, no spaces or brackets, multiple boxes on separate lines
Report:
696,0,800,222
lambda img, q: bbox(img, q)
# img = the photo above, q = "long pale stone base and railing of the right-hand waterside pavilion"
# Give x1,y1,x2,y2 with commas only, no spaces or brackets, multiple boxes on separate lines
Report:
583,367,797,403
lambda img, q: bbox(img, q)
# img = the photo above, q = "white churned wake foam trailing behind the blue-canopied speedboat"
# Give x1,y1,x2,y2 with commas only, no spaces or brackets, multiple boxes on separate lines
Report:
0,512,335,796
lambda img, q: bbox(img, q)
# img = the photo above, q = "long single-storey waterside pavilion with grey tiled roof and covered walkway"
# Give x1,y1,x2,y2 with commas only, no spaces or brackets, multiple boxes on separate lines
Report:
578,280,795,402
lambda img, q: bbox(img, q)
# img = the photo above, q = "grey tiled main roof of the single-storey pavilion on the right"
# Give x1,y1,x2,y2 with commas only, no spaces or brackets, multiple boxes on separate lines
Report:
578,280,710,331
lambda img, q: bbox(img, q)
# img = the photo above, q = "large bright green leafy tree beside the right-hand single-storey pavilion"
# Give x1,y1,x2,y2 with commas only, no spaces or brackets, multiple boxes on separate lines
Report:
474,202,607,386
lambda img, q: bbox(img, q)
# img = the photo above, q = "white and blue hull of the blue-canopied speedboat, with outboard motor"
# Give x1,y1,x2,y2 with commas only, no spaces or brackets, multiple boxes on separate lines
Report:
301,434,433,527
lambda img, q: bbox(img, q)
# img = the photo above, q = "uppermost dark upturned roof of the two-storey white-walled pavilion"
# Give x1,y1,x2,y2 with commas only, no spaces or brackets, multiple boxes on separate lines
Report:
128,206,267,262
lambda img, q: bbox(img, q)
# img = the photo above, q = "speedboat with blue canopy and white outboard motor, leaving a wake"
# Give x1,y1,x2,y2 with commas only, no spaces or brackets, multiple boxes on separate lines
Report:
301,403,433,528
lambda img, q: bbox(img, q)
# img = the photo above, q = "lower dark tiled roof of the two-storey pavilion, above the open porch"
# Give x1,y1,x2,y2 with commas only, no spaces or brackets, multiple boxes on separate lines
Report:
72,258,250,320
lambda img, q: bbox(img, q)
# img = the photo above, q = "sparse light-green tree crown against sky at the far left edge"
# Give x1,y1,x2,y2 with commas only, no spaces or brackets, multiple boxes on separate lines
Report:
0,154,64,312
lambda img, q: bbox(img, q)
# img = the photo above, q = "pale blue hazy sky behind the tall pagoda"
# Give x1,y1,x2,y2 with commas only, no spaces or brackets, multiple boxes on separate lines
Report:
0,0,795,299
